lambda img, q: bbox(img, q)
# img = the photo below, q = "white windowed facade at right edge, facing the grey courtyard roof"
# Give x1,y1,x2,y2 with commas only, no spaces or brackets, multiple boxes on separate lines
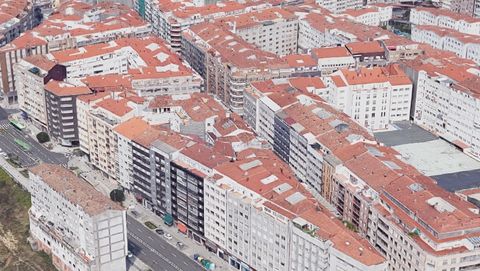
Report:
414,70,480,160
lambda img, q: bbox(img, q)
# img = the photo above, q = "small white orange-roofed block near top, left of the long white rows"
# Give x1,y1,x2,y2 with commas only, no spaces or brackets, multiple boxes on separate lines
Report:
339,4,392,26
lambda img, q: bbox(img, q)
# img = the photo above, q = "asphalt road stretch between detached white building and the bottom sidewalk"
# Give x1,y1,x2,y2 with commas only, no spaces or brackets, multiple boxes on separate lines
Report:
127,215,205,271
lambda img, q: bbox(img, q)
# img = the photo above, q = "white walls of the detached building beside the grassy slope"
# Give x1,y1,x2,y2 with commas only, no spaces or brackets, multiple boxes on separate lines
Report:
29,174,127,271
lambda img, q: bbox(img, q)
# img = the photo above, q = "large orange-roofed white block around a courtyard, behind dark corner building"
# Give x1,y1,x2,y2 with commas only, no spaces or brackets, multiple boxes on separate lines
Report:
40,36,203,97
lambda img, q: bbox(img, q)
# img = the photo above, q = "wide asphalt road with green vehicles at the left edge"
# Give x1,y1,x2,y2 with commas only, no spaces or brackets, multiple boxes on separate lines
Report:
0,108,68,167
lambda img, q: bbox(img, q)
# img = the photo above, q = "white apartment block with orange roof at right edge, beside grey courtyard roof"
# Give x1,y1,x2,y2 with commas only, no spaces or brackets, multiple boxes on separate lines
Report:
405,50,480,160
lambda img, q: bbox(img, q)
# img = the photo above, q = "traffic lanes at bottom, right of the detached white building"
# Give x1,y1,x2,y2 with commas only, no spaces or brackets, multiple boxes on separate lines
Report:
127,215,204,271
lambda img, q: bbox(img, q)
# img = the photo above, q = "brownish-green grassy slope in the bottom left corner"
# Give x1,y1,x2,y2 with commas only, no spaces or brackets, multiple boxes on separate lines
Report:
0,168,56,271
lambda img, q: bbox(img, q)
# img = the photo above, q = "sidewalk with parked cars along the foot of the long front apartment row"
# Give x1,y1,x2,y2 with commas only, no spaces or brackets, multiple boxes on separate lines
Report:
125,195,235,271
